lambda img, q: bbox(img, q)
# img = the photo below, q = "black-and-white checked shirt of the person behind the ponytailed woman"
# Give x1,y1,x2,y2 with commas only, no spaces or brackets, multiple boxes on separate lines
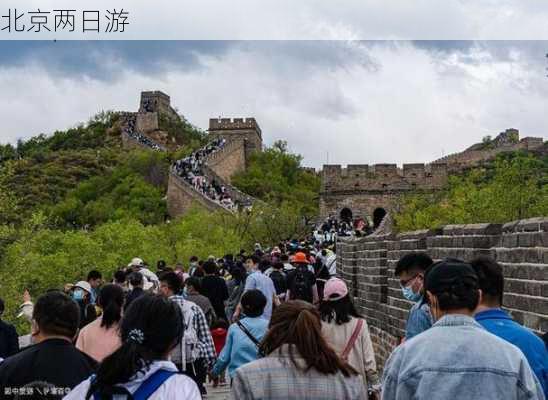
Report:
169,295,217,367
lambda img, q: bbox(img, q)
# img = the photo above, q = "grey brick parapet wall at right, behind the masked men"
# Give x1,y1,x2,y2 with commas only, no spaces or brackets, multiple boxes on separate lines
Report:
337,217,548,368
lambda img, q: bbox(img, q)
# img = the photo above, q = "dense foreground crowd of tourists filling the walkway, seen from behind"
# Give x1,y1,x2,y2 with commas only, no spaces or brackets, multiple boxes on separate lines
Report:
0,240,548,400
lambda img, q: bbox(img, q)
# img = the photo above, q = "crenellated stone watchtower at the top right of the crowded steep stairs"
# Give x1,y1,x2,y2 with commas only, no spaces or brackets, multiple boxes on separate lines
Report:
209,118,263,168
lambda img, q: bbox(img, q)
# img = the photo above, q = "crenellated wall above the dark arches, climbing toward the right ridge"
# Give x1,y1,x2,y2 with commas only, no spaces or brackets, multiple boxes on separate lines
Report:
320,128,548,218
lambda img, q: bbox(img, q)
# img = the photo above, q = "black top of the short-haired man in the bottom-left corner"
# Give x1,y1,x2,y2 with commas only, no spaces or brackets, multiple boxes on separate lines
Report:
0,339,97,395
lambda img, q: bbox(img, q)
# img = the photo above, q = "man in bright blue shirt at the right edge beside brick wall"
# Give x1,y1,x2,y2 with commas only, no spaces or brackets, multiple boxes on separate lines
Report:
470,257,548,398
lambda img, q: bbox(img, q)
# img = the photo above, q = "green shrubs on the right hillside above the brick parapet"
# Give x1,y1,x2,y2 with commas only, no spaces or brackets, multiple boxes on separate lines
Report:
394,152,548,231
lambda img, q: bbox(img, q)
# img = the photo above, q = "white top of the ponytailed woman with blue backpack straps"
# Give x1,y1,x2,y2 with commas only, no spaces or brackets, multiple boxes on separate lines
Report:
63,361,202,400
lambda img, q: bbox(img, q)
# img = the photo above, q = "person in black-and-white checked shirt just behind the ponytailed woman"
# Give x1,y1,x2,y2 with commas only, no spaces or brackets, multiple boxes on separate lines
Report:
160,272,217,394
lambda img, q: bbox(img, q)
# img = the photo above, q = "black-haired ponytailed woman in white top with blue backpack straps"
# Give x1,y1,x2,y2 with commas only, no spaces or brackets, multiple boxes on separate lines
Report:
65,294,201,400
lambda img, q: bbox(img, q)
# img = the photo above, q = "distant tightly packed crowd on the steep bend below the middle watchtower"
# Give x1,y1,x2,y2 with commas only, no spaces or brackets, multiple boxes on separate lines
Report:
172,138,245,210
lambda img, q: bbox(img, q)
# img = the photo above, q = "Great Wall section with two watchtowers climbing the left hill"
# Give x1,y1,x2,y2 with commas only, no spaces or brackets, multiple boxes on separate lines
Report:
120,91,262,217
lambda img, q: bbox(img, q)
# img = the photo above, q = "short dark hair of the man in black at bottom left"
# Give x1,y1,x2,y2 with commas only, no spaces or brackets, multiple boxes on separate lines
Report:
32,290,80,339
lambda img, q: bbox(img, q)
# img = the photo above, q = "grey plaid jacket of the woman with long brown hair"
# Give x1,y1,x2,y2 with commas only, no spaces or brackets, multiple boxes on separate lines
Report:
230,345,367,400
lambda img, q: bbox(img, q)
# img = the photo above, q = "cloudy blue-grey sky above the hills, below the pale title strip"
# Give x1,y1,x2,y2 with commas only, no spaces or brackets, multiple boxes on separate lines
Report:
0,39,548,167
